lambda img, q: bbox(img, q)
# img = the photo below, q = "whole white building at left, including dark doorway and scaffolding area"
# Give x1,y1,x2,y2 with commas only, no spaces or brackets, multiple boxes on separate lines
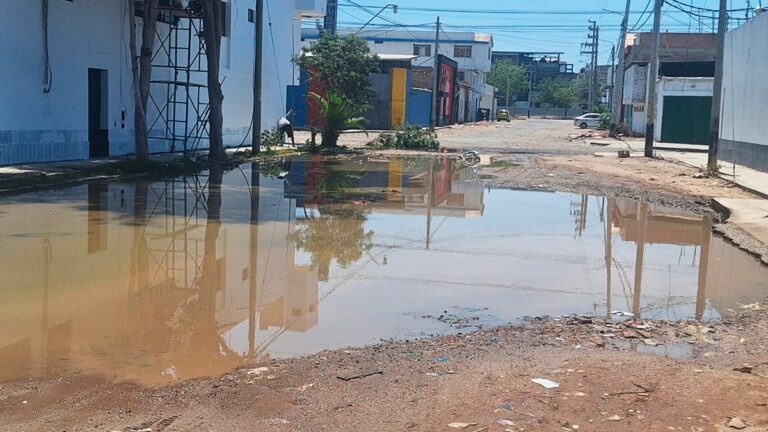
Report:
0,0,326,165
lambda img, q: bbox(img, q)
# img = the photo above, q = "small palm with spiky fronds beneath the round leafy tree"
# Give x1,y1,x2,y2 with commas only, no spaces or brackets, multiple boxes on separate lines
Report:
308,91,367,147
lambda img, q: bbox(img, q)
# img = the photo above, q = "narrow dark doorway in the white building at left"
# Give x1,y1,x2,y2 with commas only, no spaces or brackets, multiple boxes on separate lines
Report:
88,69,109,159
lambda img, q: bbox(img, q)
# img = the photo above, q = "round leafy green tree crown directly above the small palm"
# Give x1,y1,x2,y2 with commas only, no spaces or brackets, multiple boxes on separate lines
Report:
293,32,379,110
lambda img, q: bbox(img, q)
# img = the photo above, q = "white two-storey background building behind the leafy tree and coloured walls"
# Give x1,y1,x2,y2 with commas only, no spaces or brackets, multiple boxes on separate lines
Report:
302,28,493,122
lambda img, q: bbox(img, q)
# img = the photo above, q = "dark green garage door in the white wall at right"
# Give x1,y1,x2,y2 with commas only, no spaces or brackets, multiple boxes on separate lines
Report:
661,96,712,145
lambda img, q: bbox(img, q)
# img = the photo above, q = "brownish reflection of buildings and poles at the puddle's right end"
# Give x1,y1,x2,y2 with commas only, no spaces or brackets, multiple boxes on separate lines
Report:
606,199,768,319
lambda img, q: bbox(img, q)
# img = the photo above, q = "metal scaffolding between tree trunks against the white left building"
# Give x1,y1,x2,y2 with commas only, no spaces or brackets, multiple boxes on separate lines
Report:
149,6,209,154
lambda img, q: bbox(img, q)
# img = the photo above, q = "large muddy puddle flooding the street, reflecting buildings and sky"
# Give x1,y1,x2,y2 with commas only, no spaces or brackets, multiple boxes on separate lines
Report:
0,157,768,384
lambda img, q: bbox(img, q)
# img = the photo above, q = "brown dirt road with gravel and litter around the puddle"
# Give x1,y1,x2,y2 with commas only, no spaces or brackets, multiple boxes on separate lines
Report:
0,120,768,432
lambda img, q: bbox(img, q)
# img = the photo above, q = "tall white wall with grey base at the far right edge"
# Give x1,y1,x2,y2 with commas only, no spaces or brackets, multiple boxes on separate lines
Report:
720,14,768,171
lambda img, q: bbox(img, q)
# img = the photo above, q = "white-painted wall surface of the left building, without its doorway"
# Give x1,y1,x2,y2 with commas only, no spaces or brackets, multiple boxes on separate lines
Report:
0,0,325,165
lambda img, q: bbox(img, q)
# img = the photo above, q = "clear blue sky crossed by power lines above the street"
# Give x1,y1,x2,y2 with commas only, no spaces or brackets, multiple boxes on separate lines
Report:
322,0,756,70
